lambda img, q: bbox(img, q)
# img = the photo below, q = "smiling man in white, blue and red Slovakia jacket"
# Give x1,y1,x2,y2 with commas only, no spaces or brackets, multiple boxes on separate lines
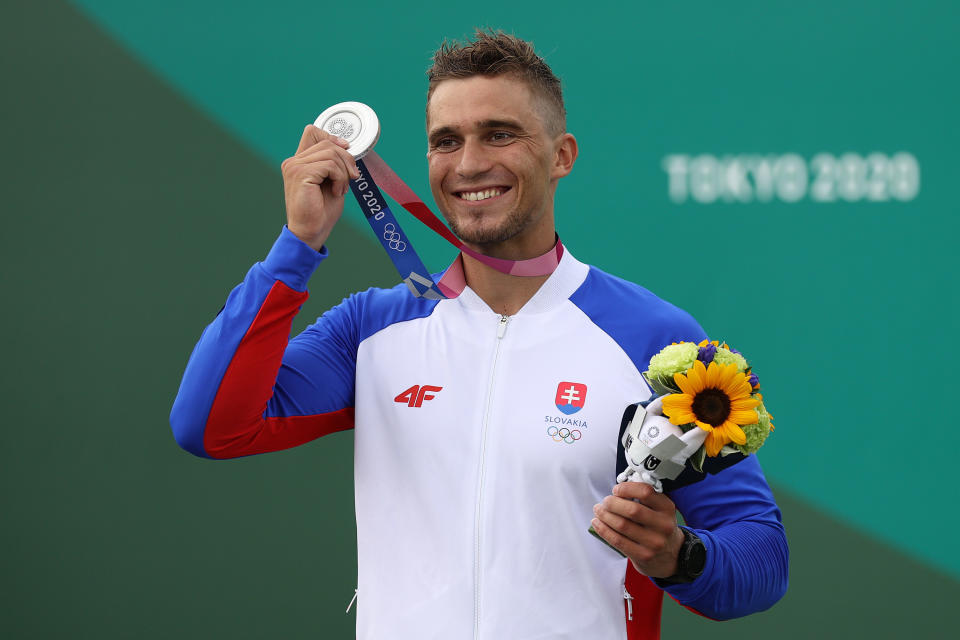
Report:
171,32,787,639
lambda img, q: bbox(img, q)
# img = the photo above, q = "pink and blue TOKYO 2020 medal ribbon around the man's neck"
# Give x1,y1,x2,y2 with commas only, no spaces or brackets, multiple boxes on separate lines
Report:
350,151,563,300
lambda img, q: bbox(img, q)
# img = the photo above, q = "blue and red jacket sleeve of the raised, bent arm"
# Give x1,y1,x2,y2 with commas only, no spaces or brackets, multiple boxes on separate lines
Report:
170,227,357,458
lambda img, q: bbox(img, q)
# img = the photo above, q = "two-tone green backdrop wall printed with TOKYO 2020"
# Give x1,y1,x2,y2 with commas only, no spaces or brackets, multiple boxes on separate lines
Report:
0,0,960,638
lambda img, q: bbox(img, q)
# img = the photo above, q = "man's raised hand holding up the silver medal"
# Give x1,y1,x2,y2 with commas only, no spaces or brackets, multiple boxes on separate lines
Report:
280,124,360,251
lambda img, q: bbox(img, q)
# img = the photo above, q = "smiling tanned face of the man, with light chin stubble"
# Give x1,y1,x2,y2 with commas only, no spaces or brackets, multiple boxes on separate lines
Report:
427,76,575,252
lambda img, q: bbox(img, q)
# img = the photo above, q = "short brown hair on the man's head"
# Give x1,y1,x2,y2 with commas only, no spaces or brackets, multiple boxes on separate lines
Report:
427,29,567,135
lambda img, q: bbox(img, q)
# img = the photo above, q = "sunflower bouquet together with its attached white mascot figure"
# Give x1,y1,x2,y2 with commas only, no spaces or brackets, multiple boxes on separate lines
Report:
617,340,773,491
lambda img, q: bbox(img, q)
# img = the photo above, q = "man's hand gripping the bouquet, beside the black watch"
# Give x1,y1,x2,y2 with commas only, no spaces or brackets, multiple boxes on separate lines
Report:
592,482,683,578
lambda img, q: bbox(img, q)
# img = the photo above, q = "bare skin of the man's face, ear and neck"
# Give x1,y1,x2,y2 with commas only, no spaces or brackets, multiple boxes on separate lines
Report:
427,72,577,316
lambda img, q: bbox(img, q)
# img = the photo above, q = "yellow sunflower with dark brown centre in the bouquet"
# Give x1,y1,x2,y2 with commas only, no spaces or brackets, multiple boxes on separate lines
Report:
663,360,760,456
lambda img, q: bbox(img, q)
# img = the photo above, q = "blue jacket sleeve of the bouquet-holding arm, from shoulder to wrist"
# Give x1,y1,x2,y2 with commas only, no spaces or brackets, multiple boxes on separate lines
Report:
570,267,787,620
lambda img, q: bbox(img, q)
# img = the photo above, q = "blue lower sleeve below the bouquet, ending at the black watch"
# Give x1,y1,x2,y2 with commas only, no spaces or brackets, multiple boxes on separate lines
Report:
664,455,789,620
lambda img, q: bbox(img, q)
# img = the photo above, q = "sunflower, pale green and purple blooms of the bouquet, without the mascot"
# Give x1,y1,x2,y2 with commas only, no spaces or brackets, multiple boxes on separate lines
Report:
643,340,773,471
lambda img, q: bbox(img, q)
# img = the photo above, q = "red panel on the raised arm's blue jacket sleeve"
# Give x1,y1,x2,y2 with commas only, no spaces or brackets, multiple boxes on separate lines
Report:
203,281,353,458
